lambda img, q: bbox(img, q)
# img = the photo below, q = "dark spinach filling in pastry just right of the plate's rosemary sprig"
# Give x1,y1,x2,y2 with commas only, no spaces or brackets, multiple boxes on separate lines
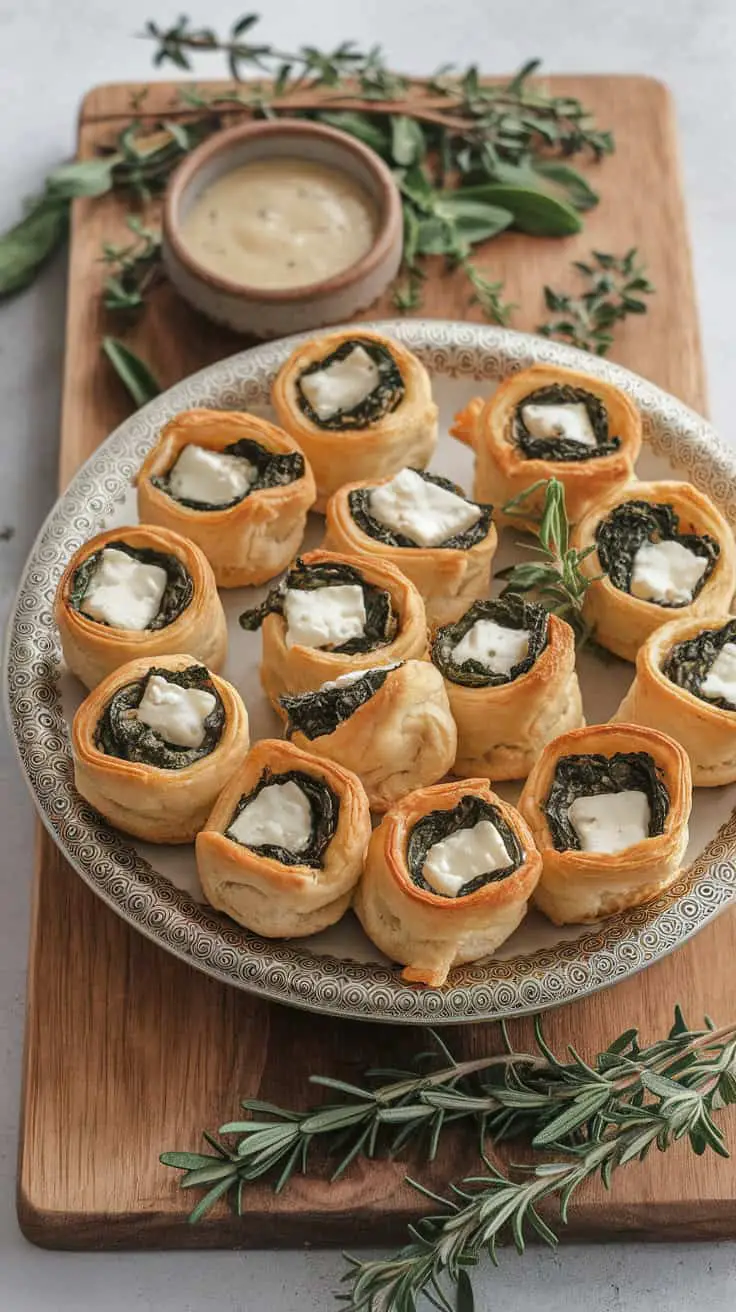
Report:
596,501,720,610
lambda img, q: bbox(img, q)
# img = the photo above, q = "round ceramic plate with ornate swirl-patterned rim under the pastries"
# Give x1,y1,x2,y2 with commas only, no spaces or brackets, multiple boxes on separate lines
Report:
7,320,736,1025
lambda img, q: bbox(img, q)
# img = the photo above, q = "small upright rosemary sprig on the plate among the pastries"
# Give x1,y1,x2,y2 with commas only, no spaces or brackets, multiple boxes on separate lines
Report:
496,479,594,640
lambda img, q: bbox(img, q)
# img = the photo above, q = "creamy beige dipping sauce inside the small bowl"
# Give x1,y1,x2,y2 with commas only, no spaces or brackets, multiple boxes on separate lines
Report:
181,157,378,290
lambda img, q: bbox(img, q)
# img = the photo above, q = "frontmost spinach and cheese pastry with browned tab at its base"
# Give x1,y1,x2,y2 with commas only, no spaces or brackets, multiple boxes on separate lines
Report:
356,779,542,988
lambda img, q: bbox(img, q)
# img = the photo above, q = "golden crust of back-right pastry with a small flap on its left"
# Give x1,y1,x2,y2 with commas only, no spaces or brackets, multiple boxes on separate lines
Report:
450,365,642,527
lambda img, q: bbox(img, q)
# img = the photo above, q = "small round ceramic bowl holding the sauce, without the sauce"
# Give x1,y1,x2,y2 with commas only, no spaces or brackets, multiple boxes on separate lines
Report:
163,119,401,337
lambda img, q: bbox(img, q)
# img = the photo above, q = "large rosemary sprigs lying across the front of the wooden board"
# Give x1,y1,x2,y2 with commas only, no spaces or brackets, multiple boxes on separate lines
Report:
161,1008,736,1312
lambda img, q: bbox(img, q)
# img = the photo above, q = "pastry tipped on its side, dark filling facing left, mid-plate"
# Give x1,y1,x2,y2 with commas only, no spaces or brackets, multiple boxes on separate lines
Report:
281,660,458,811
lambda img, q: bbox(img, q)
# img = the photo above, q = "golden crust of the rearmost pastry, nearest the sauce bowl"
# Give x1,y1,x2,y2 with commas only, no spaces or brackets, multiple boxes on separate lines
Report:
273,328,437,510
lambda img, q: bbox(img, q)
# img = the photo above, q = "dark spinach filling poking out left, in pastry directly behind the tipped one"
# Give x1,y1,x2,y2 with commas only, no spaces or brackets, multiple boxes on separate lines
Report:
240,558,399,656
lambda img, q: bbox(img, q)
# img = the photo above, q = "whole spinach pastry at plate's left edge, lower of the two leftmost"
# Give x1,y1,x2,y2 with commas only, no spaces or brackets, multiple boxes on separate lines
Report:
72,655,248,844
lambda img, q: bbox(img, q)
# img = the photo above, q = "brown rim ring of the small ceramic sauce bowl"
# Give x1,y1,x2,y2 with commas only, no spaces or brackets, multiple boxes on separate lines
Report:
161,118,401,306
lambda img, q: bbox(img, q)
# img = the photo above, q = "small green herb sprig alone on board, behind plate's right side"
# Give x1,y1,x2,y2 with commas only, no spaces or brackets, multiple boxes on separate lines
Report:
537,247,655,356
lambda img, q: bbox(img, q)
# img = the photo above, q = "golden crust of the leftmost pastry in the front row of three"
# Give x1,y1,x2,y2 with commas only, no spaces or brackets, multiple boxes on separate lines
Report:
197,739,370,938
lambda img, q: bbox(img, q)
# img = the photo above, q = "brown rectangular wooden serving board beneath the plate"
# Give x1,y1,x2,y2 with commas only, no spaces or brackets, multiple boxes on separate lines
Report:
18,77,736,1249
